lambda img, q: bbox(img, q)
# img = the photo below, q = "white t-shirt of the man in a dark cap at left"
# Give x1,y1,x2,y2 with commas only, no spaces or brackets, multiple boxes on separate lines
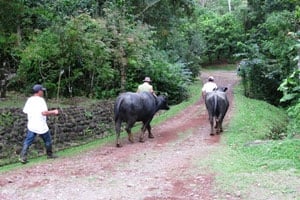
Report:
23,96,49,134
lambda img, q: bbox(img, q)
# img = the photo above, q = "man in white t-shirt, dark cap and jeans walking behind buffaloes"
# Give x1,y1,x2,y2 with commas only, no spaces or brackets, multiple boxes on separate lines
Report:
19,84,58,164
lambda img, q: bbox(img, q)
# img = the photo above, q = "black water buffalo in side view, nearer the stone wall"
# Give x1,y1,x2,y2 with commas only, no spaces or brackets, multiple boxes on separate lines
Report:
114,92,169,147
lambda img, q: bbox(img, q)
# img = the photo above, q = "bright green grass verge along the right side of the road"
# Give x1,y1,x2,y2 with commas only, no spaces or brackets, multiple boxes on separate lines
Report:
224,84,300,170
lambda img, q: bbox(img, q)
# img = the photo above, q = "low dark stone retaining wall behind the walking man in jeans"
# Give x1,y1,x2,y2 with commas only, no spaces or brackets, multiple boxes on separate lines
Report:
0,101,114,166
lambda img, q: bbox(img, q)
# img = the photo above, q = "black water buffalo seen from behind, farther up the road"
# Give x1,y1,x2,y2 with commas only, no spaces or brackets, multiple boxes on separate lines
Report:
205,87,229,135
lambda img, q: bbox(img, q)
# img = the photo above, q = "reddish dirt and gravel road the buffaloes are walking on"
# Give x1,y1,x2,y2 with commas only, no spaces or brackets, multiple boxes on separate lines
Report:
0,71,238,200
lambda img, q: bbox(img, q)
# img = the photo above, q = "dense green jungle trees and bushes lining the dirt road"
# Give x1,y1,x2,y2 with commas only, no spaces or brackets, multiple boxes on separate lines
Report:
0,0,300,137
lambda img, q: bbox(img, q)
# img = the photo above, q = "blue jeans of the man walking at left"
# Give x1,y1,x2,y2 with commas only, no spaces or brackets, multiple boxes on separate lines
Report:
20,130,52,160
